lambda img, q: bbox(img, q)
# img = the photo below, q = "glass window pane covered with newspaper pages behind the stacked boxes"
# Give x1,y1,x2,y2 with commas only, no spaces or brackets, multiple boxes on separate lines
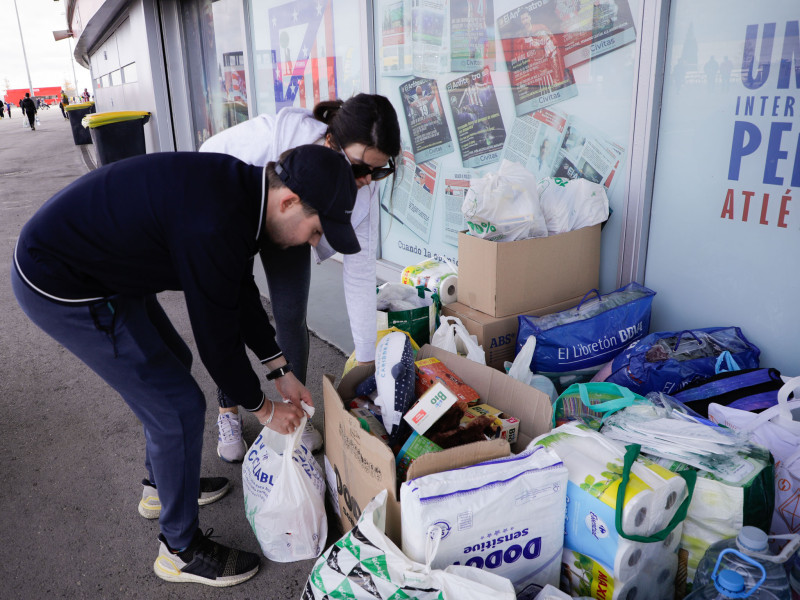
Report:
374,0,640,290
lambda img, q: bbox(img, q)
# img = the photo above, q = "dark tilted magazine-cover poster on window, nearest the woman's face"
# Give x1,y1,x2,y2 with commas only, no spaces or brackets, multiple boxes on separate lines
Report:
400,77,453,163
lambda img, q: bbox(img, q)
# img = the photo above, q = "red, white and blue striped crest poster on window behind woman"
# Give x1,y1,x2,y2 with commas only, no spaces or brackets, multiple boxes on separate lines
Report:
269,0,338,111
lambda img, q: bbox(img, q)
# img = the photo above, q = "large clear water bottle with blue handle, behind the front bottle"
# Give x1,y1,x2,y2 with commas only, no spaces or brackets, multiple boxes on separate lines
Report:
692,526,791,600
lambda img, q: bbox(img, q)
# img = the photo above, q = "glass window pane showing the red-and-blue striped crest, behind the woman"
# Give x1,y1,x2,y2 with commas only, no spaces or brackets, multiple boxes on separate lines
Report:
250,0,369,114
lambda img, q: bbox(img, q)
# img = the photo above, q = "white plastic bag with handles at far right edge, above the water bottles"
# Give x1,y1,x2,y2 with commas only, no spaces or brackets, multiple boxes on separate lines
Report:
708,377,800,535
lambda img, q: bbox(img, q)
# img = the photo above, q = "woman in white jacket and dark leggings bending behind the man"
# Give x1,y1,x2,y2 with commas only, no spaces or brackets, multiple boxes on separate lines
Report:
200,94,400,462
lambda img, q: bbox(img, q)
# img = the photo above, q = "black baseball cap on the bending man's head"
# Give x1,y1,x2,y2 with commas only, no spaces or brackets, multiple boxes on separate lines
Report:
275,144,361,254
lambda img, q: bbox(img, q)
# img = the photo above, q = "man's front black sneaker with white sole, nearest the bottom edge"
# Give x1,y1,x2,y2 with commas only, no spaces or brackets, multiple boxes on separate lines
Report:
153,529,261,587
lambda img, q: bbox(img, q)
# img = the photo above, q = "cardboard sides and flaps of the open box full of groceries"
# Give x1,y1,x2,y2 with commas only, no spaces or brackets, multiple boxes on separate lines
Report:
322,345,553,545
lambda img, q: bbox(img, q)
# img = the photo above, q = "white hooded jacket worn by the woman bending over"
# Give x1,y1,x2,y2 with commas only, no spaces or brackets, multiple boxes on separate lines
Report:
200,108,379,361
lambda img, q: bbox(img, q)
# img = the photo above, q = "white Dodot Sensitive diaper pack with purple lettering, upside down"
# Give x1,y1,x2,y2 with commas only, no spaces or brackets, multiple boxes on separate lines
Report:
400,445,567,593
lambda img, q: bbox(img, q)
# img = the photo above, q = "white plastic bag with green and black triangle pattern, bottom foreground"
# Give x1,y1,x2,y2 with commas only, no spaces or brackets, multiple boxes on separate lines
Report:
302,490,515,600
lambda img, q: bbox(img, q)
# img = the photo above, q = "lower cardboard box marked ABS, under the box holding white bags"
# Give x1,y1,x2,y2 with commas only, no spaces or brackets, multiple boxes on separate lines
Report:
442,296,589,372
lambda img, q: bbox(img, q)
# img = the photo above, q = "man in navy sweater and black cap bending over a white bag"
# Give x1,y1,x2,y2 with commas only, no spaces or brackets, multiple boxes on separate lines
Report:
11,145,360,587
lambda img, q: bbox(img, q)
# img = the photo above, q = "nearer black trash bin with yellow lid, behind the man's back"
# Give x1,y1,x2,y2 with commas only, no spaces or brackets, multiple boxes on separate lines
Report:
83,110,150,165
